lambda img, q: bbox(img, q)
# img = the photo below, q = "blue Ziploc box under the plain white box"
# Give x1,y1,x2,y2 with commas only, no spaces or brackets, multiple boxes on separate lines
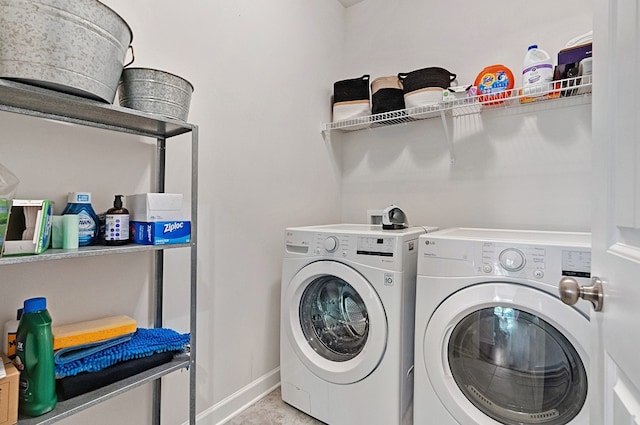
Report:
129,220,191,245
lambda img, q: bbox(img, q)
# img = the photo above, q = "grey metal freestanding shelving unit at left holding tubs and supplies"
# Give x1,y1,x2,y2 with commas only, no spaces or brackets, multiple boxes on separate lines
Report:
0,79,198,425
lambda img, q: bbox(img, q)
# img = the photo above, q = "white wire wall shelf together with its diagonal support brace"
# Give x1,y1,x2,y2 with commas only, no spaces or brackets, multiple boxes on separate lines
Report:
322,75,592,163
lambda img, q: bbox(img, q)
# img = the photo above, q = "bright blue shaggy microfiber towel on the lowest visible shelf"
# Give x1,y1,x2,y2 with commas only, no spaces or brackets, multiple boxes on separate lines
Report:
55,328,190,378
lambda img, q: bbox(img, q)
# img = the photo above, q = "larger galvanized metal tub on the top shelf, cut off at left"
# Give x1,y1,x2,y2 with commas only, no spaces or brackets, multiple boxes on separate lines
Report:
0,0,133,103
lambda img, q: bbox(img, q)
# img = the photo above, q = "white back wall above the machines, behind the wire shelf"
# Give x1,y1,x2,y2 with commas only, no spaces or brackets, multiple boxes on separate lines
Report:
334,0,592,230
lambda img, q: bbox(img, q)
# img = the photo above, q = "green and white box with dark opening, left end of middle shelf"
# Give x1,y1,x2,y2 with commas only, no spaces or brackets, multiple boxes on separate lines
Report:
1,199,53,256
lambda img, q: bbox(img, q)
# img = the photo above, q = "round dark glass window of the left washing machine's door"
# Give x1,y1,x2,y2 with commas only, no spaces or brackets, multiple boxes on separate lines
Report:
300,276,369,362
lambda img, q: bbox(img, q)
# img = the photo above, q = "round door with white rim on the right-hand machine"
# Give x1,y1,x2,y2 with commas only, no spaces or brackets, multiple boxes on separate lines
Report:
423,283,589,425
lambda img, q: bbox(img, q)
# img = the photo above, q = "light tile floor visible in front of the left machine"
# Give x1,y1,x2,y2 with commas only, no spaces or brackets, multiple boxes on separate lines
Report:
224,387,323,425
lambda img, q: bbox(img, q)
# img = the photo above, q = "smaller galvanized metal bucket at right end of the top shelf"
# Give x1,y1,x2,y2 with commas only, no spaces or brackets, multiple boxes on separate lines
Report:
118,68,193,121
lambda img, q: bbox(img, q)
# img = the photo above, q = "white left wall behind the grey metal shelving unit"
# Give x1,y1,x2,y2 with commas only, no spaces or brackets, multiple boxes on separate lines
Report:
0,0,344,424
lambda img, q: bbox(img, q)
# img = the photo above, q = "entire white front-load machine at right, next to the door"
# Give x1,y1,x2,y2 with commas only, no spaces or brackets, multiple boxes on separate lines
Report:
414,228,592,425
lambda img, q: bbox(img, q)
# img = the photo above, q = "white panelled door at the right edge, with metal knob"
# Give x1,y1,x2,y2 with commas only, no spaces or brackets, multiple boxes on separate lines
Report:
579,0,640,425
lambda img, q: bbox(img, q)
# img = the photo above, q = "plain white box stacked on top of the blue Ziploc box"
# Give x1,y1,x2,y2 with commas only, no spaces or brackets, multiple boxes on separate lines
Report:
127,193,188,223
